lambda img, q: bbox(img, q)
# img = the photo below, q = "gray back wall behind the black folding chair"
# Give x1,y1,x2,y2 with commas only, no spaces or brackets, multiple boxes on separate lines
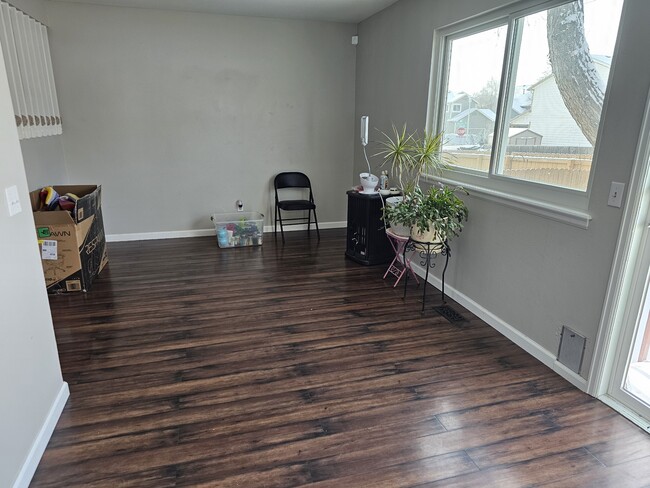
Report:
41,2,356,234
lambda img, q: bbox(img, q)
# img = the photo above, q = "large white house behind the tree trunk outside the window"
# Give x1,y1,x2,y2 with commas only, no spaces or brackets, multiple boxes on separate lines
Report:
510,56,611,147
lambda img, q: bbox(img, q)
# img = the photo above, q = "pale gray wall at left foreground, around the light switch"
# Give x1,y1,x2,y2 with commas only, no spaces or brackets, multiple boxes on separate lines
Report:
0,41,63,487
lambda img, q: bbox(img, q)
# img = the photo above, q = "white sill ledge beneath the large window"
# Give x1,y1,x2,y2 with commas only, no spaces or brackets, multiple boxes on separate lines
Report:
426,177,591,229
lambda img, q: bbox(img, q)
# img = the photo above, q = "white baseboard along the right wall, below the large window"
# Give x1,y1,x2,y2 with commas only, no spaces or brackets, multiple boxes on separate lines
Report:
411,262,587,392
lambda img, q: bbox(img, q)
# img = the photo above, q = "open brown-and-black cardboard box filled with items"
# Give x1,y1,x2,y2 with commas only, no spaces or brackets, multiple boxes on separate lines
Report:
29,185,108,293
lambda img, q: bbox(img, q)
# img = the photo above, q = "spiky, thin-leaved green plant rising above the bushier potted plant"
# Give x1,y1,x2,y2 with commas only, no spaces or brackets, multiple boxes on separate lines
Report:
375,124,448,193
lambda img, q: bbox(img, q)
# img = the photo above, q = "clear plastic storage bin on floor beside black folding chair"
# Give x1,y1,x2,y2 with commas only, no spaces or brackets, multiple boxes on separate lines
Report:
211,212,264,248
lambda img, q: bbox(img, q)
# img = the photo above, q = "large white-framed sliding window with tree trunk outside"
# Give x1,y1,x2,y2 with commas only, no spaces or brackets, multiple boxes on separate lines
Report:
436,0,623,192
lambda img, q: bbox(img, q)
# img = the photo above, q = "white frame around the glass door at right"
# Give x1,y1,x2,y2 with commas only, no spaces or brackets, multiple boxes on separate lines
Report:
587,86,650,430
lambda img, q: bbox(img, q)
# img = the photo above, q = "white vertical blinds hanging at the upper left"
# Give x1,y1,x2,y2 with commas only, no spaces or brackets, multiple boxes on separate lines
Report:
0,0,62,139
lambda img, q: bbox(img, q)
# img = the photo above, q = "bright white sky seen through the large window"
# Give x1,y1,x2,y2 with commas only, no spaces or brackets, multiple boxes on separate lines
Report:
449,0,623,94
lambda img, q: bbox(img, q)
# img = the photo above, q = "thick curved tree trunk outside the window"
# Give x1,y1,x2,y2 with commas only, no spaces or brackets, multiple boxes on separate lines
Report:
546,0,605,146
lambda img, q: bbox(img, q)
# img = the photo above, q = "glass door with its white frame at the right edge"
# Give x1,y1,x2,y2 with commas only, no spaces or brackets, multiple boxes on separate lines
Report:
588,87,650,432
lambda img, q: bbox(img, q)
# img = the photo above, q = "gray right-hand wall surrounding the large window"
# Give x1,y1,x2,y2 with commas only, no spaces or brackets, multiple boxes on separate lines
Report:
355,0,650,377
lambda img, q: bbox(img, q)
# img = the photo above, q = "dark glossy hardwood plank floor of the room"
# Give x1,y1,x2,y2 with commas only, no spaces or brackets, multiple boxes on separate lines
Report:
32,230,650,488
